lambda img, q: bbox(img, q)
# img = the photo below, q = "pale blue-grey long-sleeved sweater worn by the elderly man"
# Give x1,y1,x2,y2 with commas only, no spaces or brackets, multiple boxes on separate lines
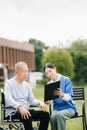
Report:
4,78,40,116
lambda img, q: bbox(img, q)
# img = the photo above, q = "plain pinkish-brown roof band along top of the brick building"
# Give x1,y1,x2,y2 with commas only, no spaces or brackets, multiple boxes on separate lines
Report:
0,37,34,52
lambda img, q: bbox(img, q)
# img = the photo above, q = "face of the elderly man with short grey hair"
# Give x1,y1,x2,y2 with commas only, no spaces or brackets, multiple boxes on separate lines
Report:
16,65,29,81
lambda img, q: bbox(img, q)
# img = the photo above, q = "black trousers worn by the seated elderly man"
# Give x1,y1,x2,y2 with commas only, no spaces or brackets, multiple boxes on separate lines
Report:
7,110,50,130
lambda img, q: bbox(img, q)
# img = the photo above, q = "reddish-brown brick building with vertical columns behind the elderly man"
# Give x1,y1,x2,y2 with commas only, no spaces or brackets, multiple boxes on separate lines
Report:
0,38,35,83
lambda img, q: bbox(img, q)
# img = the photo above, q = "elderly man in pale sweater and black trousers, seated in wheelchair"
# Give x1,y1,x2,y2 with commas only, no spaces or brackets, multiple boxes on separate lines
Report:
5,62,50,130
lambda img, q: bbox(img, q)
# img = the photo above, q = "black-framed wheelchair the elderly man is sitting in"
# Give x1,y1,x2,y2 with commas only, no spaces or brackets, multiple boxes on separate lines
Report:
0,89,39,130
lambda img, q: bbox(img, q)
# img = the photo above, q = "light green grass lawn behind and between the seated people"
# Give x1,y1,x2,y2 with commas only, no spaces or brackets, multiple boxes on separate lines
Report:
0,85,87,130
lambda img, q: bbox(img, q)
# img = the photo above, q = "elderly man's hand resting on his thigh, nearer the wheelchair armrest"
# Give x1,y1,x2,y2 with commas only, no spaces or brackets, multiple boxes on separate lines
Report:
18,106,31,119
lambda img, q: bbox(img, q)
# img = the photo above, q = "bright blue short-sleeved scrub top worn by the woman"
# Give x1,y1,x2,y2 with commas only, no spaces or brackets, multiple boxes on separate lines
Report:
48,75,77,111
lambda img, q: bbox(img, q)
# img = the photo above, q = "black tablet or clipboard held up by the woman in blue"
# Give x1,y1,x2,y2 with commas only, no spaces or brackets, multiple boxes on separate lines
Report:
44,81,60,101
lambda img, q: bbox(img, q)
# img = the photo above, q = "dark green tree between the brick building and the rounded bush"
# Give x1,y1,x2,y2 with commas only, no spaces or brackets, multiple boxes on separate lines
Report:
29,39,48,71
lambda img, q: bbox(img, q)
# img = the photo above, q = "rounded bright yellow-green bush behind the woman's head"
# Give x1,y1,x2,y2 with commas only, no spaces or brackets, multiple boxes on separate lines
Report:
42,47,74,79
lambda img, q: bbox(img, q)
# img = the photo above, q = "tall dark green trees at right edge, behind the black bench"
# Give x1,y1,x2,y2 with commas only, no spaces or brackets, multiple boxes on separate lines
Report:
69,40,87,82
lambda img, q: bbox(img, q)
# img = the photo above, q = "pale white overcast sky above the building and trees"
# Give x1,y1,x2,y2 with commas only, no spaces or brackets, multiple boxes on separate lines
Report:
0,0,87,46
